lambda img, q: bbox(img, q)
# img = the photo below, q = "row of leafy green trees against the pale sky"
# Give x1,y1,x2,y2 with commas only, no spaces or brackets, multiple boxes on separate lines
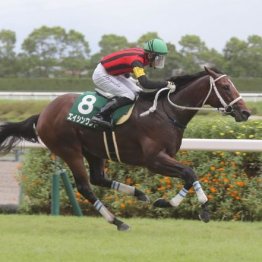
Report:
0,26,262,78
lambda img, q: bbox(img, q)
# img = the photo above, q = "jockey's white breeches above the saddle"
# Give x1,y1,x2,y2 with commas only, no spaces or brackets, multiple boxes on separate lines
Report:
92,63,141,100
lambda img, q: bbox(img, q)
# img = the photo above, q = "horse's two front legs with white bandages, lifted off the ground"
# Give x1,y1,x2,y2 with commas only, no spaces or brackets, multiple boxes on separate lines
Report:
149,152,209,222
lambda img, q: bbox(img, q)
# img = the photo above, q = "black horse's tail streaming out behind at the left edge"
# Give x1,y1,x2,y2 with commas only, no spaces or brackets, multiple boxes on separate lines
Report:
0,115,39,154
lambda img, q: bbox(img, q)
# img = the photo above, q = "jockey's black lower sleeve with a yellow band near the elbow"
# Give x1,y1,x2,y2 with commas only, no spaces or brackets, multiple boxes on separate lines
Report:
133,63,167,89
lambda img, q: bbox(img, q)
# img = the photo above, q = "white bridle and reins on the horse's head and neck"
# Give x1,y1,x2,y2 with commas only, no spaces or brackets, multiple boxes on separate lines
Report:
140,75,242,116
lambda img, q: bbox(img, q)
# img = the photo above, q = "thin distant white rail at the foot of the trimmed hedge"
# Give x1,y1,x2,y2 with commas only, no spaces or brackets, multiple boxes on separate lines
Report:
0,91,262,102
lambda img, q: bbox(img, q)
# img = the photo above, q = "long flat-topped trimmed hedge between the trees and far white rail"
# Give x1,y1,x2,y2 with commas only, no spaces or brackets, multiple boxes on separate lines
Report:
0,78,262,92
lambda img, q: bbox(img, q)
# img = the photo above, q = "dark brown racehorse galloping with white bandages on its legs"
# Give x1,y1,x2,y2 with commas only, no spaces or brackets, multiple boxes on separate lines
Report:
0,68,250,231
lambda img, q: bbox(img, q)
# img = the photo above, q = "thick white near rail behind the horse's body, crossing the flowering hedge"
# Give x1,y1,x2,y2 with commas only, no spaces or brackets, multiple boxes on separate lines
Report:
18,138,262,152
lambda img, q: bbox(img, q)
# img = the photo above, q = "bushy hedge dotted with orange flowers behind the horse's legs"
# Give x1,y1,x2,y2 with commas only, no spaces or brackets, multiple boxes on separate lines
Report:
19,117,262,221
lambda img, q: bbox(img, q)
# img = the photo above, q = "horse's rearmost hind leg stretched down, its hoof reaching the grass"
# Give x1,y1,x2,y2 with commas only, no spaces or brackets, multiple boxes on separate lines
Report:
56,148,129,231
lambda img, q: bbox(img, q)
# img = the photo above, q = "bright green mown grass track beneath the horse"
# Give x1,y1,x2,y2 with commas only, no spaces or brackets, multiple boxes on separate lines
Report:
0,215,262,262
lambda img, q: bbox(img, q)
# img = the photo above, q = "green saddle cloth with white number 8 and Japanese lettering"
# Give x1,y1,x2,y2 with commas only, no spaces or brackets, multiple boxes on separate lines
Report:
66,91,134,129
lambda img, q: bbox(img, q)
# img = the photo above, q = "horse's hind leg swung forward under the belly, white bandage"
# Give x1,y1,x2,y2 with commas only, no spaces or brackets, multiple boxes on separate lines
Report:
84,152,149,202
